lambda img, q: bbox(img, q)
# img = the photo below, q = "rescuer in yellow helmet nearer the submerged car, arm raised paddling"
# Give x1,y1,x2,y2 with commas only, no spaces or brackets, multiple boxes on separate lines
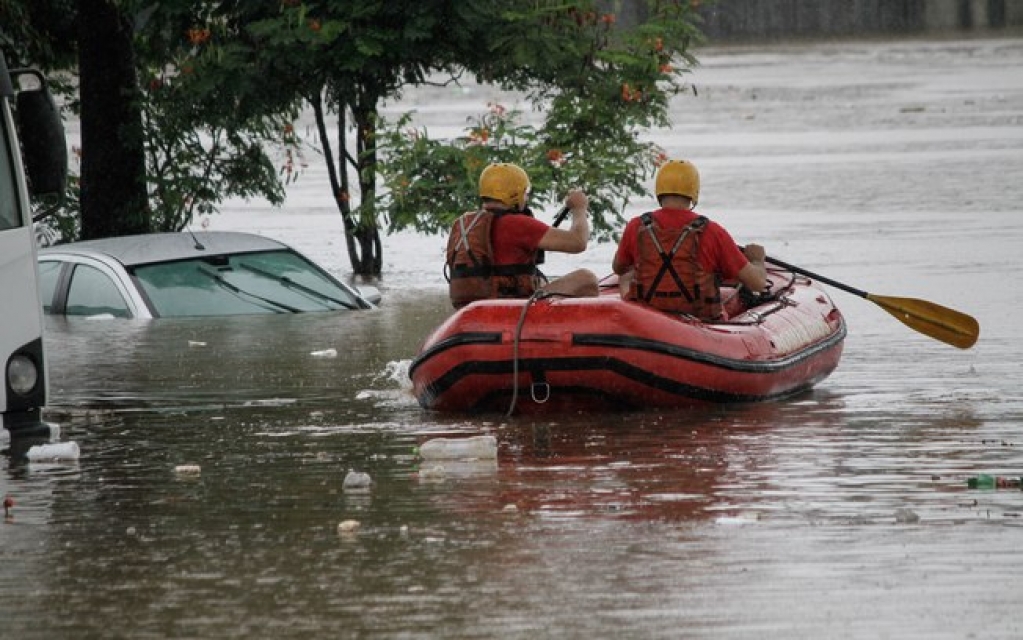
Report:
445,163,598,308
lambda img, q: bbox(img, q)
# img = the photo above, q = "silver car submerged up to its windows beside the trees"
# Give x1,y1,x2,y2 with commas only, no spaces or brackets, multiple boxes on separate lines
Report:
39,231,380,318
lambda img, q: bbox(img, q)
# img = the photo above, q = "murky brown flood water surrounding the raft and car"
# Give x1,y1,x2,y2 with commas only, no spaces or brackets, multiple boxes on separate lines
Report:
6,39,1023,639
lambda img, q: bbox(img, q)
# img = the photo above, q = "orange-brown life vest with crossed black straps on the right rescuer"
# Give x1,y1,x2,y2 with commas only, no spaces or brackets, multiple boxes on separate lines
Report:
627,213,723,321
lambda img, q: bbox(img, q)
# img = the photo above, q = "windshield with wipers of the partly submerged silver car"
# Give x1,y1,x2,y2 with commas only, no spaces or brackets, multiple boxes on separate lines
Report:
132,250,361,317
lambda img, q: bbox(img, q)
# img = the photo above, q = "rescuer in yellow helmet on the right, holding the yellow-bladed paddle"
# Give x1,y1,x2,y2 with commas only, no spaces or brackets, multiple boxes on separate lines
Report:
612,161,767,321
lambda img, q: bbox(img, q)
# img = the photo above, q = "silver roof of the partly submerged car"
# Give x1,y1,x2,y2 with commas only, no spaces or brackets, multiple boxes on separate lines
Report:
39,231,291,267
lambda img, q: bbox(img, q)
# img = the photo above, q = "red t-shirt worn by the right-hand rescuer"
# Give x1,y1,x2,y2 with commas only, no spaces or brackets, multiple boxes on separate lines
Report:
614,209,749,280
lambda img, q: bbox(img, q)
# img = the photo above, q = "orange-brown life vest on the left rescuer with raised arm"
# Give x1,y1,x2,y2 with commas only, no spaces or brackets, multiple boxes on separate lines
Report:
444,210,539,309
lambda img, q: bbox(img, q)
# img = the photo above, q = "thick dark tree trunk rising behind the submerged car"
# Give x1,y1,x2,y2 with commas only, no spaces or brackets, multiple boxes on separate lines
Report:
78,0,150,239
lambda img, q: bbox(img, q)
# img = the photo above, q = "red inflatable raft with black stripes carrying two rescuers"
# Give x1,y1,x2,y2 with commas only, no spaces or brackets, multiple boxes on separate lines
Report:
409,269,846,413
